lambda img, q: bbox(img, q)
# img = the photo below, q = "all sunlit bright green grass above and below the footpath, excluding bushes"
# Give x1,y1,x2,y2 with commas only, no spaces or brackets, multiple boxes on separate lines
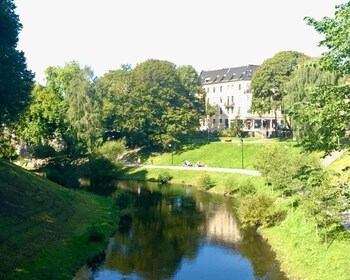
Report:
119,142,350,280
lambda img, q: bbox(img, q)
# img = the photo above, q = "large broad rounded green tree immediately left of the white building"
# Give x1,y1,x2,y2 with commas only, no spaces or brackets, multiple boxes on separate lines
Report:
98,60,203,148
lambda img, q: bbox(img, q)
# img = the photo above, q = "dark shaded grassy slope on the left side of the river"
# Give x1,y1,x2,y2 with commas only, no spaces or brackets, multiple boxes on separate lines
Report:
0,160,116,279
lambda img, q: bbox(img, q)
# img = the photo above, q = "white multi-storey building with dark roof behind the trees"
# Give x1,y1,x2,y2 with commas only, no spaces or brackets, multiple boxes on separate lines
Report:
201,65,282,137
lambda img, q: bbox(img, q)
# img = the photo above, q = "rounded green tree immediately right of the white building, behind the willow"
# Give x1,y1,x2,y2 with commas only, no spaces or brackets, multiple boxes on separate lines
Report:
251,51,308,117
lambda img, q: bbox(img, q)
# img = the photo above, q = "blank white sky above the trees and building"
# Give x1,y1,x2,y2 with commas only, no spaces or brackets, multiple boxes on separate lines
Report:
14,0,346,83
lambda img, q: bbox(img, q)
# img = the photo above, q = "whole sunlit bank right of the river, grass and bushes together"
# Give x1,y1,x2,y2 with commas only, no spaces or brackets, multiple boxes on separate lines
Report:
122,141,350,280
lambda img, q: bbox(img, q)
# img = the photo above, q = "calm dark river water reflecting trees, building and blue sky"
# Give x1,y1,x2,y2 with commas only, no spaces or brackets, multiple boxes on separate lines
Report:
75,181,287,280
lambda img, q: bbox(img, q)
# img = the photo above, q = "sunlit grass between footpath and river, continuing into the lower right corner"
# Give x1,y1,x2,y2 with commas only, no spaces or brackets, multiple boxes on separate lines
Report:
118,150,350,280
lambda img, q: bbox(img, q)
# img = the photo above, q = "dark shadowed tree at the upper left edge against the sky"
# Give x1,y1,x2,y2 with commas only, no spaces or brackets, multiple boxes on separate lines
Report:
0,0,34,126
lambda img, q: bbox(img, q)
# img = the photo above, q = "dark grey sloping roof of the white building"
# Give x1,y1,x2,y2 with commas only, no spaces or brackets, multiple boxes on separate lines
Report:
201,64,259,85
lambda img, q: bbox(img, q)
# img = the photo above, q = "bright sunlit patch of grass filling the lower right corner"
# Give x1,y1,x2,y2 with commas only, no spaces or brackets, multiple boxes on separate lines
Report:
261,209,350,280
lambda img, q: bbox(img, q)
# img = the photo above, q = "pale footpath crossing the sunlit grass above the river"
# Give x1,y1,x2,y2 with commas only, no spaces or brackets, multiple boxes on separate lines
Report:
124,164,260,176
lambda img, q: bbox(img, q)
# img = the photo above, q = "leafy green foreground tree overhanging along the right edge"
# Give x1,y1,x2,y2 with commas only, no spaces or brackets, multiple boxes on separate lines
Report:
295,2,350,153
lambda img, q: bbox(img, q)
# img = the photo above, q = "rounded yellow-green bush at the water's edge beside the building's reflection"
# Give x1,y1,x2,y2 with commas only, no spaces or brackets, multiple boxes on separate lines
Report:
238,193,274,228
